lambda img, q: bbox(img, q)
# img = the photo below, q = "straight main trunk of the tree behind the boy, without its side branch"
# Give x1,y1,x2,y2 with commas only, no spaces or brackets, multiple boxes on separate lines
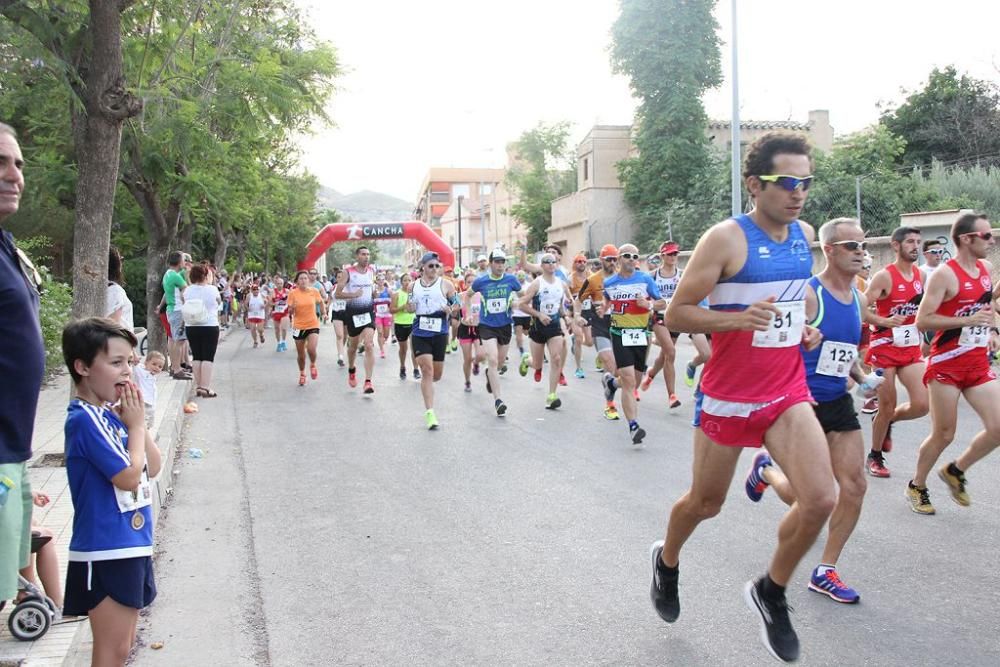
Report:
72,0,142,317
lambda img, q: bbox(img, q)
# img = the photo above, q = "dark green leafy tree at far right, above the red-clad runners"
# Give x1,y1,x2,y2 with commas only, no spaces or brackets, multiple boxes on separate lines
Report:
881,66,1000,165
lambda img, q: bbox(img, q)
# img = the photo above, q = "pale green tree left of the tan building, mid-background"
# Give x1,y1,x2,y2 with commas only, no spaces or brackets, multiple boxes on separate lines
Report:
504,121,576,247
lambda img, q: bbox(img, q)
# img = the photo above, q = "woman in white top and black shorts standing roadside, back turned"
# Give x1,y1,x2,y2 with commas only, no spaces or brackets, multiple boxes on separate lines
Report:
181,264,222,398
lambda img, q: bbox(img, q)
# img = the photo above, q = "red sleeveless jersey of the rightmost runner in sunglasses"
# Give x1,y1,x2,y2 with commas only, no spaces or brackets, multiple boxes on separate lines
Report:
930,259,993,367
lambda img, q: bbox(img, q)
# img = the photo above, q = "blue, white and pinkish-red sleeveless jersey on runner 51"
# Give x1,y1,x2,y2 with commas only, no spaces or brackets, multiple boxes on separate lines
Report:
701,214,812,403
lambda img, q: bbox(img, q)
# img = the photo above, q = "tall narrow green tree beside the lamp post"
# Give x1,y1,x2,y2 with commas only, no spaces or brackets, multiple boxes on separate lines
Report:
611,0,722,250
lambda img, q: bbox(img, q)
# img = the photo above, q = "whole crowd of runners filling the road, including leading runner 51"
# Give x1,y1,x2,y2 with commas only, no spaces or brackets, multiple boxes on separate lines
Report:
213,133,1000,660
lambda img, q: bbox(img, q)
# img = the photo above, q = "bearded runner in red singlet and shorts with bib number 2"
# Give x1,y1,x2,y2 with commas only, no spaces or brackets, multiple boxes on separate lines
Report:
865,227,927,477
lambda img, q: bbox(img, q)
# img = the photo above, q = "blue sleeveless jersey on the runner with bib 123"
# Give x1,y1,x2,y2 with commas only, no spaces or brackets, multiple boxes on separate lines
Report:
802,276,861,403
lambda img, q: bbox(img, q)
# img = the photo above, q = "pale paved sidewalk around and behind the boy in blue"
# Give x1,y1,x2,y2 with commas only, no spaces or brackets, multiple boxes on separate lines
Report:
0,331,226,667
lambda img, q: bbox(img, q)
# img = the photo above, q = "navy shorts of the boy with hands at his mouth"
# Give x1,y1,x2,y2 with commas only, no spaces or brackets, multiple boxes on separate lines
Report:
63,556,156,616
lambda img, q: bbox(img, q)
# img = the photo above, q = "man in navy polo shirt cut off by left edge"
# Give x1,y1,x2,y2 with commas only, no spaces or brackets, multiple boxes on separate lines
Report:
0,123,45,600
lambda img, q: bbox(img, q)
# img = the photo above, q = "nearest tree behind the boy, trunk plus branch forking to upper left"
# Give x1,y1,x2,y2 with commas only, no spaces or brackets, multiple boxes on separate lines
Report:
0,0,142,317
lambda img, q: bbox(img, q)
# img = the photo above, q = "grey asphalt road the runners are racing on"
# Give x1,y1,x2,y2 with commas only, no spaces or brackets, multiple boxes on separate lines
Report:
135,327,1000,666
